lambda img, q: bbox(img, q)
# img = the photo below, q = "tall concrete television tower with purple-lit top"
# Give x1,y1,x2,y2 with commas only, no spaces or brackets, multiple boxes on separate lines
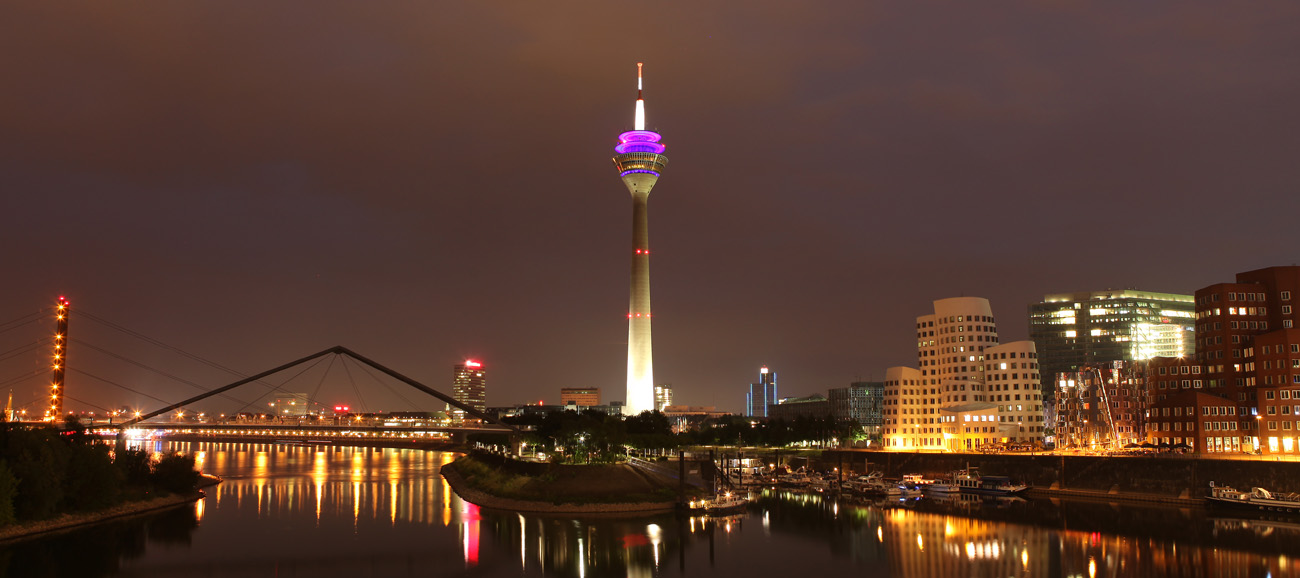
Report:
614,62,668,416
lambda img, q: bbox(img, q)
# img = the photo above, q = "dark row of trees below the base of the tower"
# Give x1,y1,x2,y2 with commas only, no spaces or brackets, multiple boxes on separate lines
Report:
478,410,861,464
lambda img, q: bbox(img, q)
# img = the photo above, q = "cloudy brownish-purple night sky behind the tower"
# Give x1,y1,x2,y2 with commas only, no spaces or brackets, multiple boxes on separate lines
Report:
0,0,1300,412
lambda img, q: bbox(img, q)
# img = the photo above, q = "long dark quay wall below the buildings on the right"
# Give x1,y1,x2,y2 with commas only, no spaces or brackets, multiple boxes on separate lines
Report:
811,451,1300,496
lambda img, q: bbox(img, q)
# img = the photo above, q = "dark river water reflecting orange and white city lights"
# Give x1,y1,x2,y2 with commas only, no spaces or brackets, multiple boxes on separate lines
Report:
0,443,1300,578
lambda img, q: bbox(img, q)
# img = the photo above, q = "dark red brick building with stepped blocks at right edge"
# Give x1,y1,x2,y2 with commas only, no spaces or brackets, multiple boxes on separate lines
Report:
1147,266,1300,455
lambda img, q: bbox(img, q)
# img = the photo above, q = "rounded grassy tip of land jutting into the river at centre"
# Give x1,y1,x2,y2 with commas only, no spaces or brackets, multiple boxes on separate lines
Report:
442,456,677,514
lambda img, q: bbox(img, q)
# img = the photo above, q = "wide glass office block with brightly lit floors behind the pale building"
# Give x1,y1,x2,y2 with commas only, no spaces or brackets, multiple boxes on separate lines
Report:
1030,290,1196,396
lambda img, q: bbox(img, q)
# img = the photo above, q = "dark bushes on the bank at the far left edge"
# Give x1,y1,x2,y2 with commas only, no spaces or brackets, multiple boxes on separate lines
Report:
0,418,199,525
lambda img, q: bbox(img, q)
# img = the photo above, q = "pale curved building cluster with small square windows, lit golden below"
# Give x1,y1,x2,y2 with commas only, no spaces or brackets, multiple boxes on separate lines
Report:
884,297,1044,451
